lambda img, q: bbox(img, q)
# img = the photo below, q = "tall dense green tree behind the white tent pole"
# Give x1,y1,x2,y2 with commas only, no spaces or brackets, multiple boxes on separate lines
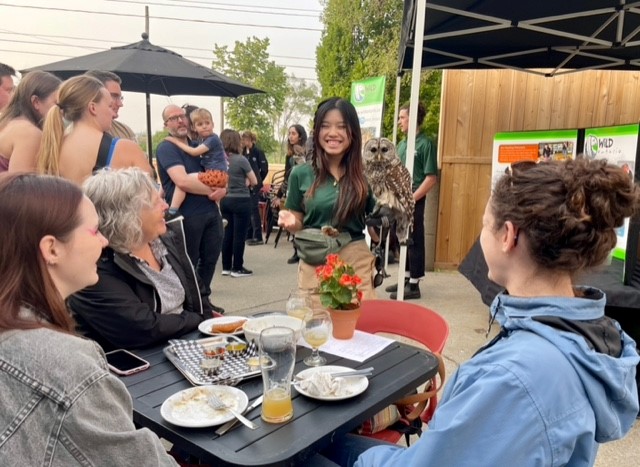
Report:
316,0,442,143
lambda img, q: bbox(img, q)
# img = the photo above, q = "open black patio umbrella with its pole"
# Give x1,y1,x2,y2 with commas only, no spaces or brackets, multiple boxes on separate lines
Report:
23,33,263,162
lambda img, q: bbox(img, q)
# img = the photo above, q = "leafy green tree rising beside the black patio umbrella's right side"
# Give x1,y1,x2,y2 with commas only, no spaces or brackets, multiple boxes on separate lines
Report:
212,37,288,154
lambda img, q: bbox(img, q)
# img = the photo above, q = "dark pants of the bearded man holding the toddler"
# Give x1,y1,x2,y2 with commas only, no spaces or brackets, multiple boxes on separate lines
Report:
183,206,222,295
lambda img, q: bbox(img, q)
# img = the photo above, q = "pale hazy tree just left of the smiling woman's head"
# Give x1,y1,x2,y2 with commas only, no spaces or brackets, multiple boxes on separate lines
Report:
273,76,320,162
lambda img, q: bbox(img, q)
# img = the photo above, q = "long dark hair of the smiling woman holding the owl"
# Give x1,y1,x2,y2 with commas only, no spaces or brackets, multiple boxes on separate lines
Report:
307,97,369,227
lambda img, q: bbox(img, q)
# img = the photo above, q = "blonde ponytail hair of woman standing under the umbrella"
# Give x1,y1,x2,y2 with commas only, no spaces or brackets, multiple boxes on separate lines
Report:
37,75,104,175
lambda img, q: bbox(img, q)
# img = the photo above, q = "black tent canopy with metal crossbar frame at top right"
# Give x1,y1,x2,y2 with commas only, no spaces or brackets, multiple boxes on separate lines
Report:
399,0,640,75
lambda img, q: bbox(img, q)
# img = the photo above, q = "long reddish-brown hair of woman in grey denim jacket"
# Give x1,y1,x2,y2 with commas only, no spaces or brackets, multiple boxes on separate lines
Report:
0,173,83,332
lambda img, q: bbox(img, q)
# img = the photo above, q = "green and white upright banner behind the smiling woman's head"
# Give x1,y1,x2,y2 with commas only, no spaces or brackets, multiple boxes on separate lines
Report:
351,76,386,146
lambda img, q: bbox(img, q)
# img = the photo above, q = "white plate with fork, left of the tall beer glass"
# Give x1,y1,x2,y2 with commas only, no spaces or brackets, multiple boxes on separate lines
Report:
160,385,249,428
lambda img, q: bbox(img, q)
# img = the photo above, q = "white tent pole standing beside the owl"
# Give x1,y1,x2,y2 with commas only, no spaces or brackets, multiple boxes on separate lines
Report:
397,0,427,300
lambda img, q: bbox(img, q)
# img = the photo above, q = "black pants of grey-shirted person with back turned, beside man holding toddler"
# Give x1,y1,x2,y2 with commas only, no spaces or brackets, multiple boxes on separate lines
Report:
220,196,251,271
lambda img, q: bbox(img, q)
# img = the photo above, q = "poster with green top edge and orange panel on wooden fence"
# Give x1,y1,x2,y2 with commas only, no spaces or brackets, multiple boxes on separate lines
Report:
491,130,578,185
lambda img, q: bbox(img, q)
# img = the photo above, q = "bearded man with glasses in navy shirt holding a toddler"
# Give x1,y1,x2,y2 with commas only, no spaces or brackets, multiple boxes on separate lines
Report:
156,105,227,313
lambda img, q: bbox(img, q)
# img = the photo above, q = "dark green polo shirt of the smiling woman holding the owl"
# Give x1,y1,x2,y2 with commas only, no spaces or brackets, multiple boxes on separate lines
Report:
285,163,375,240
